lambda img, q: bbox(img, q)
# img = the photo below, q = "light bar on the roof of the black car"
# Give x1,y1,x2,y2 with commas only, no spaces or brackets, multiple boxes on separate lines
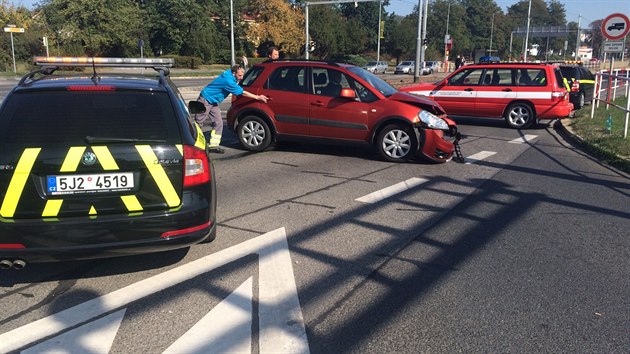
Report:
33,57,175,68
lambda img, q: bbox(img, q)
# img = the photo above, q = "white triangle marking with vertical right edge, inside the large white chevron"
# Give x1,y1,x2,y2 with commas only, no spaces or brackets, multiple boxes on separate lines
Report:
164,277,253,354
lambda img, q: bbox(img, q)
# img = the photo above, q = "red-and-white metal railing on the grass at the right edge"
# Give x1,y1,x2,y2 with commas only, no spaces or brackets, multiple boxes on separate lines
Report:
591,68,630,139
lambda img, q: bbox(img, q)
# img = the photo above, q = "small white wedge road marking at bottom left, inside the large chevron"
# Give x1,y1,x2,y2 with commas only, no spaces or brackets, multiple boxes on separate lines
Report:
21,309,126,354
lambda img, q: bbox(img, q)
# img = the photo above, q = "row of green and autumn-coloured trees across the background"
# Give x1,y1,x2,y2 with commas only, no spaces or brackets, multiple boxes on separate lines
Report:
0,0,604,69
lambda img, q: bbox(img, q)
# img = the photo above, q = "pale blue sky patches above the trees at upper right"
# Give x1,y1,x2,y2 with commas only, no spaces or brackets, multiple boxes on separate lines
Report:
386,0,630,28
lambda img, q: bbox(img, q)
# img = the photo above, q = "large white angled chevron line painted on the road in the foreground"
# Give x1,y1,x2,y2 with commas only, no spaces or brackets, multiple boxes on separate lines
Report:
0,228,309,353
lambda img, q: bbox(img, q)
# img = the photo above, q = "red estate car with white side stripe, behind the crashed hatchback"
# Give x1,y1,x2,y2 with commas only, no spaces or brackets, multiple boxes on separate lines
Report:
401,63,573,129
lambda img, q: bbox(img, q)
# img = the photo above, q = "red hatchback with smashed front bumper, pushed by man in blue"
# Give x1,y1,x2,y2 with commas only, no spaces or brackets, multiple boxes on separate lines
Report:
227,61,459,162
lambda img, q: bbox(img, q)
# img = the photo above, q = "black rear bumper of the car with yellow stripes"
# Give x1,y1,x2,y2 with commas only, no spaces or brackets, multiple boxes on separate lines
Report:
0,193,216,262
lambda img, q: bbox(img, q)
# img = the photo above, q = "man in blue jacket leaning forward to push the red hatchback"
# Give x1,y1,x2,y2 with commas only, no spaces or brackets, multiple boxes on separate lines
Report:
195,65,269,154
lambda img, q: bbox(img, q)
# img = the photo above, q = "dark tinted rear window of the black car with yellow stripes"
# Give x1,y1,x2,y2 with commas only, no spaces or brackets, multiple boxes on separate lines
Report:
0,91,181,146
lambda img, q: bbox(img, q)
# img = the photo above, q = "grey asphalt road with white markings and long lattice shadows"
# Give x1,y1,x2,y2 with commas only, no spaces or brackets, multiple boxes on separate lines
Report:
0,76,630,353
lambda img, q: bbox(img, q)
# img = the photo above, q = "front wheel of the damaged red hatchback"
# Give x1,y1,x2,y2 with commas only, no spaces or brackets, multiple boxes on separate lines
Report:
376,124,418,162
